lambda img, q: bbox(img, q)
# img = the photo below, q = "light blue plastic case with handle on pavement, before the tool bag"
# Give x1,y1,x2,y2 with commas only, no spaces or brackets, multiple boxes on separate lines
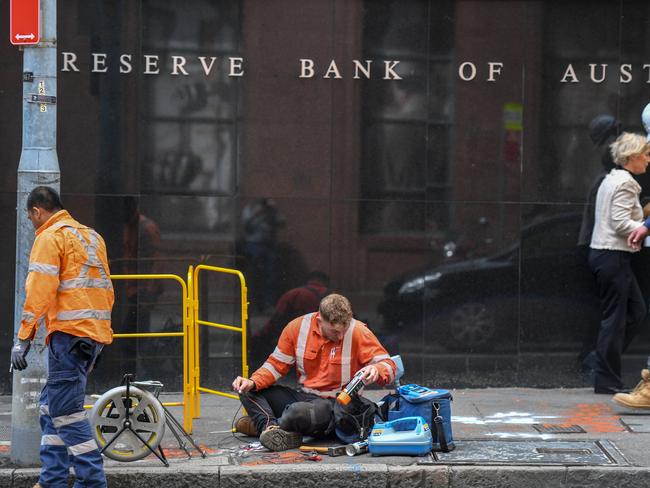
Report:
368,417,433,456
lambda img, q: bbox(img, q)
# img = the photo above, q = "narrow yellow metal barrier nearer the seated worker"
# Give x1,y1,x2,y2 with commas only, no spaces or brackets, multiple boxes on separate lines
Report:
188,264,248,428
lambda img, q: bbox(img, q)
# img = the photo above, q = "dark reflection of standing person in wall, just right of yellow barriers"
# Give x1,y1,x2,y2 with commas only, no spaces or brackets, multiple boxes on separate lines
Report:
242,198,285,312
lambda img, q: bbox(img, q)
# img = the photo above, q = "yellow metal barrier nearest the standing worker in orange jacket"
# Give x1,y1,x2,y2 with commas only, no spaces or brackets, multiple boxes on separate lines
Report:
111,274,194,432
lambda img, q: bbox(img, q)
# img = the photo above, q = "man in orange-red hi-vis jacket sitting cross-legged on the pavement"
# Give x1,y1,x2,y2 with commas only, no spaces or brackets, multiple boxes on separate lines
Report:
232,294,396,451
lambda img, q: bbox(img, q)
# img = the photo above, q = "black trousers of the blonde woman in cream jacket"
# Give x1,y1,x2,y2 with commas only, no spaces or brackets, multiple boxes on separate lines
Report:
589,249,648,388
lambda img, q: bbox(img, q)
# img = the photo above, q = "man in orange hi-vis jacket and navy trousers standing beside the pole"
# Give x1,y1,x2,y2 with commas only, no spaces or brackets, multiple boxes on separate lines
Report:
11,186,115,488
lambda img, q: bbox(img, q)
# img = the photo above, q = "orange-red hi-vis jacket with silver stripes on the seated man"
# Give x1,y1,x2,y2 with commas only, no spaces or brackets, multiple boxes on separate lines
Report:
251,313,396,398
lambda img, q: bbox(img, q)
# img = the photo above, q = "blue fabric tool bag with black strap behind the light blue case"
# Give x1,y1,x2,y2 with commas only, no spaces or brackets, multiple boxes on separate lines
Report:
387,384,456,452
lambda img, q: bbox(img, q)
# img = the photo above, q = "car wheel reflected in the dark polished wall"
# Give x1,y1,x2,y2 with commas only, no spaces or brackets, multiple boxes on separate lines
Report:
445,302,496,349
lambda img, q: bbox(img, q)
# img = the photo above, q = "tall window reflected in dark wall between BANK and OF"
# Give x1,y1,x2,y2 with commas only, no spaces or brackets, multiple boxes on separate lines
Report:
360,1,453,235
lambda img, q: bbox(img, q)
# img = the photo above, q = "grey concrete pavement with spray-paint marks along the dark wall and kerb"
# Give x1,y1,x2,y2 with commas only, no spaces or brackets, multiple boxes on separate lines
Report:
0,388,650,488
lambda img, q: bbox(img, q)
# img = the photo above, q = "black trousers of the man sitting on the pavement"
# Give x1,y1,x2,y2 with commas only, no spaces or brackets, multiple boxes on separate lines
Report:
239,385,334,435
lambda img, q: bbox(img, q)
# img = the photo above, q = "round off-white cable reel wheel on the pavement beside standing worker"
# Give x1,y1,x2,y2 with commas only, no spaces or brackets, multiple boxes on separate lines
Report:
89,386,165,461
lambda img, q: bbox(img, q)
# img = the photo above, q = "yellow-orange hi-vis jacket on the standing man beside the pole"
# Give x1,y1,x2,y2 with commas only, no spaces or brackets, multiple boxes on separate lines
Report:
18,210,115,344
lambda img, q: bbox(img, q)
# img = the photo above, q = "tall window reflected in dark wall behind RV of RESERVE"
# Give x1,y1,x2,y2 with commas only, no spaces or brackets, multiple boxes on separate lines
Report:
143,0,240,232
